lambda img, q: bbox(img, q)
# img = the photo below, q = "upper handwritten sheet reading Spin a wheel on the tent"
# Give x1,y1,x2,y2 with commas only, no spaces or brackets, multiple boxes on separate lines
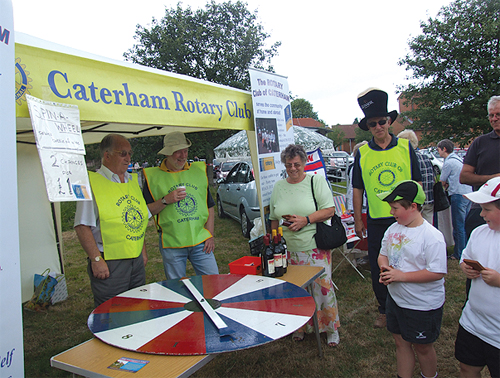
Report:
26,95,85,155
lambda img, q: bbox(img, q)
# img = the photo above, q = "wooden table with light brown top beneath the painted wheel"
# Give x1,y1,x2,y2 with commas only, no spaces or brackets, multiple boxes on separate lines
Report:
50,265,324,378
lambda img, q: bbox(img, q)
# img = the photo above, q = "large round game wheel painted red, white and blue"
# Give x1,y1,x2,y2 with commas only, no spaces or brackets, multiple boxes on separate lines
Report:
88,274,315,355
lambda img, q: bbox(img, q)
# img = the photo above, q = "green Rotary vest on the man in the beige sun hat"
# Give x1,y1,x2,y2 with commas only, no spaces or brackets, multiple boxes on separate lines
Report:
144,162,212,248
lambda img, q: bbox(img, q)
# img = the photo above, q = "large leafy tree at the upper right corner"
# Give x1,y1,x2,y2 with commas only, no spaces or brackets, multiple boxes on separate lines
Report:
398,0,500,145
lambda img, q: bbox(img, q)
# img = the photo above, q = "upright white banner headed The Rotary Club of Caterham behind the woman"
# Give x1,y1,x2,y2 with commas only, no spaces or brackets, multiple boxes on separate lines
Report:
250,69,294,217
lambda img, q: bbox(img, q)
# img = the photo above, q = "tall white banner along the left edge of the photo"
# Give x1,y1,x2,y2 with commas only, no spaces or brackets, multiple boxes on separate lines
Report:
0,0,24,377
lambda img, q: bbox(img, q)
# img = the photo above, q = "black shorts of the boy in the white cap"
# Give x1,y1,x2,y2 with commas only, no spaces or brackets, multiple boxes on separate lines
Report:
455,325,500,377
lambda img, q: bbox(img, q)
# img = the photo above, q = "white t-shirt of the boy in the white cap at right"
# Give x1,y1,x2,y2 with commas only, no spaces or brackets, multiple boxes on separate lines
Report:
460,224,500,349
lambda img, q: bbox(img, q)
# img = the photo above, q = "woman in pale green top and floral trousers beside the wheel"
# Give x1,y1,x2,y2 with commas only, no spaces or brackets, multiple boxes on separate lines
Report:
269,144,340,347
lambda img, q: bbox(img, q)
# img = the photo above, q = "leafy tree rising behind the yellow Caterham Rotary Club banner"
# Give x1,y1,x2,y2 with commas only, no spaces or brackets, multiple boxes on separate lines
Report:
124,0,281,89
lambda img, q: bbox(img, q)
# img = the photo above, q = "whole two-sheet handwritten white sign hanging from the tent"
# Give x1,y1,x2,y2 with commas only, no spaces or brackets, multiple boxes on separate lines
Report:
26,95,92,202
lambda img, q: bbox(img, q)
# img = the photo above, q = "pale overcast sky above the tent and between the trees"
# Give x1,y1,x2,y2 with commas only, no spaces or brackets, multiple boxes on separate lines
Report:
12,0,451,125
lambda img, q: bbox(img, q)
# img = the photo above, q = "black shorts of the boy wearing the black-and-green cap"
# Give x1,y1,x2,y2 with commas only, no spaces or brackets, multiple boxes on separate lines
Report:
385,293,443,344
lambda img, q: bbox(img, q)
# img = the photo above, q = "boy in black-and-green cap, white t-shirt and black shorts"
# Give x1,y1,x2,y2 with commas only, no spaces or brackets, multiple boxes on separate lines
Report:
377,180,447,378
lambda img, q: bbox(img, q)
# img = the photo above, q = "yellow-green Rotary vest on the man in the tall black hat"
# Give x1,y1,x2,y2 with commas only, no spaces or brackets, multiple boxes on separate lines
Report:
359,139,411,219
